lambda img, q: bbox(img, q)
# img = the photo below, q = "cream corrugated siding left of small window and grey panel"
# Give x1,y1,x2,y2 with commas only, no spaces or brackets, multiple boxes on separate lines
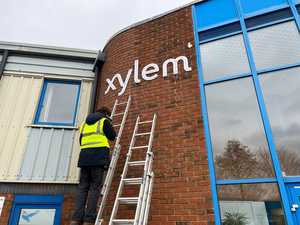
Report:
0,76,42,180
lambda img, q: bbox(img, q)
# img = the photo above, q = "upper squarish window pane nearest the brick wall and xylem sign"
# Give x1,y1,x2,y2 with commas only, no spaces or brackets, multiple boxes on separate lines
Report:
200,35,250,80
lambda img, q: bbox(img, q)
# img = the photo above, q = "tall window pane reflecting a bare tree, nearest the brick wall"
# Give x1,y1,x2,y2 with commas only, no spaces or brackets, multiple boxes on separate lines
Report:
205,78,274,179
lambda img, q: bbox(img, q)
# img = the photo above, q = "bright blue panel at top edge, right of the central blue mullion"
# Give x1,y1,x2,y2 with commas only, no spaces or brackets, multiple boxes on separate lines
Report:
241,0,287,14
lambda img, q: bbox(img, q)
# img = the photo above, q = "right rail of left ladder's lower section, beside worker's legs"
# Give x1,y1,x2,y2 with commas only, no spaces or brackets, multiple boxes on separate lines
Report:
95,145,121,225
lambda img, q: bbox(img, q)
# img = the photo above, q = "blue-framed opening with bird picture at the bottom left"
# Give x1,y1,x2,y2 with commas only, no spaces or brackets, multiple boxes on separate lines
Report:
8,195,63,225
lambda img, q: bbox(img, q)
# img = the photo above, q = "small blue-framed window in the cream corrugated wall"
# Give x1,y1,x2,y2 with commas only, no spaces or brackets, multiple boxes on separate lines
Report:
35,81,80,125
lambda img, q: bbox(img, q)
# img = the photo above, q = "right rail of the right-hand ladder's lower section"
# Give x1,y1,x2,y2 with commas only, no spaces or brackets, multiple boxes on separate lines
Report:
138,153,153,224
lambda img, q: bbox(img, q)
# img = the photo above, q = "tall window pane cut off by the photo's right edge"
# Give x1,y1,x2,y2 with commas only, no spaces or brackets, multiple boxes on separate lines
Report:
260,67,300,175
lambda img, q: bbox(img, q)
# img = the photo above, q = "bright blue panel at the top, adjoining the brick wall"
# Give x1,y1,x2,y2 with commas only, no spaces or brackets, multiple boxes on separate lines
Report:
195,0,238,30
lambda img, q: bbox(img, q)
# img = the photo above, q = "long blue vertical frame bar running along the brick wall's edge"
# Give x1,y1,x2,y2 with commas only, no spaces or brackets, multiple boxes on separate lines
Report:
192,5,221,225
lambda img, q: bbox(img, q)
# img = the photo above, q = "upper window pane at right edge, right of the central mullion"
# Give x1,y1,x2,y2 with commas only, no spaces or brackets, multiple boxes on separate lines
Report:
249,21,300,69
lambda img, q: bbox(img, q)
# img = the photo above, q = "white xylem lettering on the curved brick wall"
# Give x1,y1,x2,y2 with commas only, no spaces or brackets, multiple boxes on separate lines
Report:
105,56,192,96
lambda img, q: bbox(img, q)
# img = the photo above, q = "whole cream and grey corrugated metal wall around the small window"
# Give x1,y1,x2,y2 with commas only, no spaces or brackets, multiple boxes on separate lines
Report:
0,74,92,183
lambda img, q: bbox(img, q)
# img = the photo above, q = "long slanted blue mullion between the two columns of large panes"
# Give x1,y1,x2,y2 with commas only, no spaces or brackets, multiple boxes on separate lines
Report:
235,0,293,225
